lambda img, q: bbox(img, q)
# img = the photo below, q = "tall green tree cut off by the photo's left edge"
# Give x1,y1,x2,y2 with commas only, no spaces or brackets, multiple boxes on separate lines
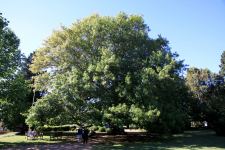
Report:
0,15,30,129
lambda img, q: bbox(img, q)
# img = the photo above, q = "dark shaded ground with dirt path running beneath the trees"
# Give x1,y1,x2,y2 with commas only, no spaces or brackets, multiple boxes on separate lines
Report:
0,130,225,150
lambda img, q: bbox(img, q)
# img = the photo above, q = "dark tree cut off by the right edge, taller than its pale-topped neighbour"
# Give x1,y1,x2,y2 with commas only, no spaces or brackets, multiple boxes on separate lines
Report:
204,52,225,136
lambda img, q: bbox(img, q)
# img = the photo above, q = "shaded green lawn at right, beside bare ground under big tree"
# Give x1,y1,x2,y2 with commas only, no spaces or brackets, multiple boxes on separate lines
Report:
93,130,225,150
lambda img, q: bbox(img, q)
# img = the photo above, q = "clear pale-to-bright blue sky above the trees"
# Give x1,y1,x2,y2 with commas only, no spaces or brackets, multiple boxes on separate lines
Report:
0,0,225,72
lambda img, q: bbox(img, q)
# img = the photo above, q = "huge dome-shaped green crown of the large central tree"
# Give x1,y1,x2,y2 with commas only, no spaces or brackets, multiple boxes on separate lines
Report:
27,13,188,132
